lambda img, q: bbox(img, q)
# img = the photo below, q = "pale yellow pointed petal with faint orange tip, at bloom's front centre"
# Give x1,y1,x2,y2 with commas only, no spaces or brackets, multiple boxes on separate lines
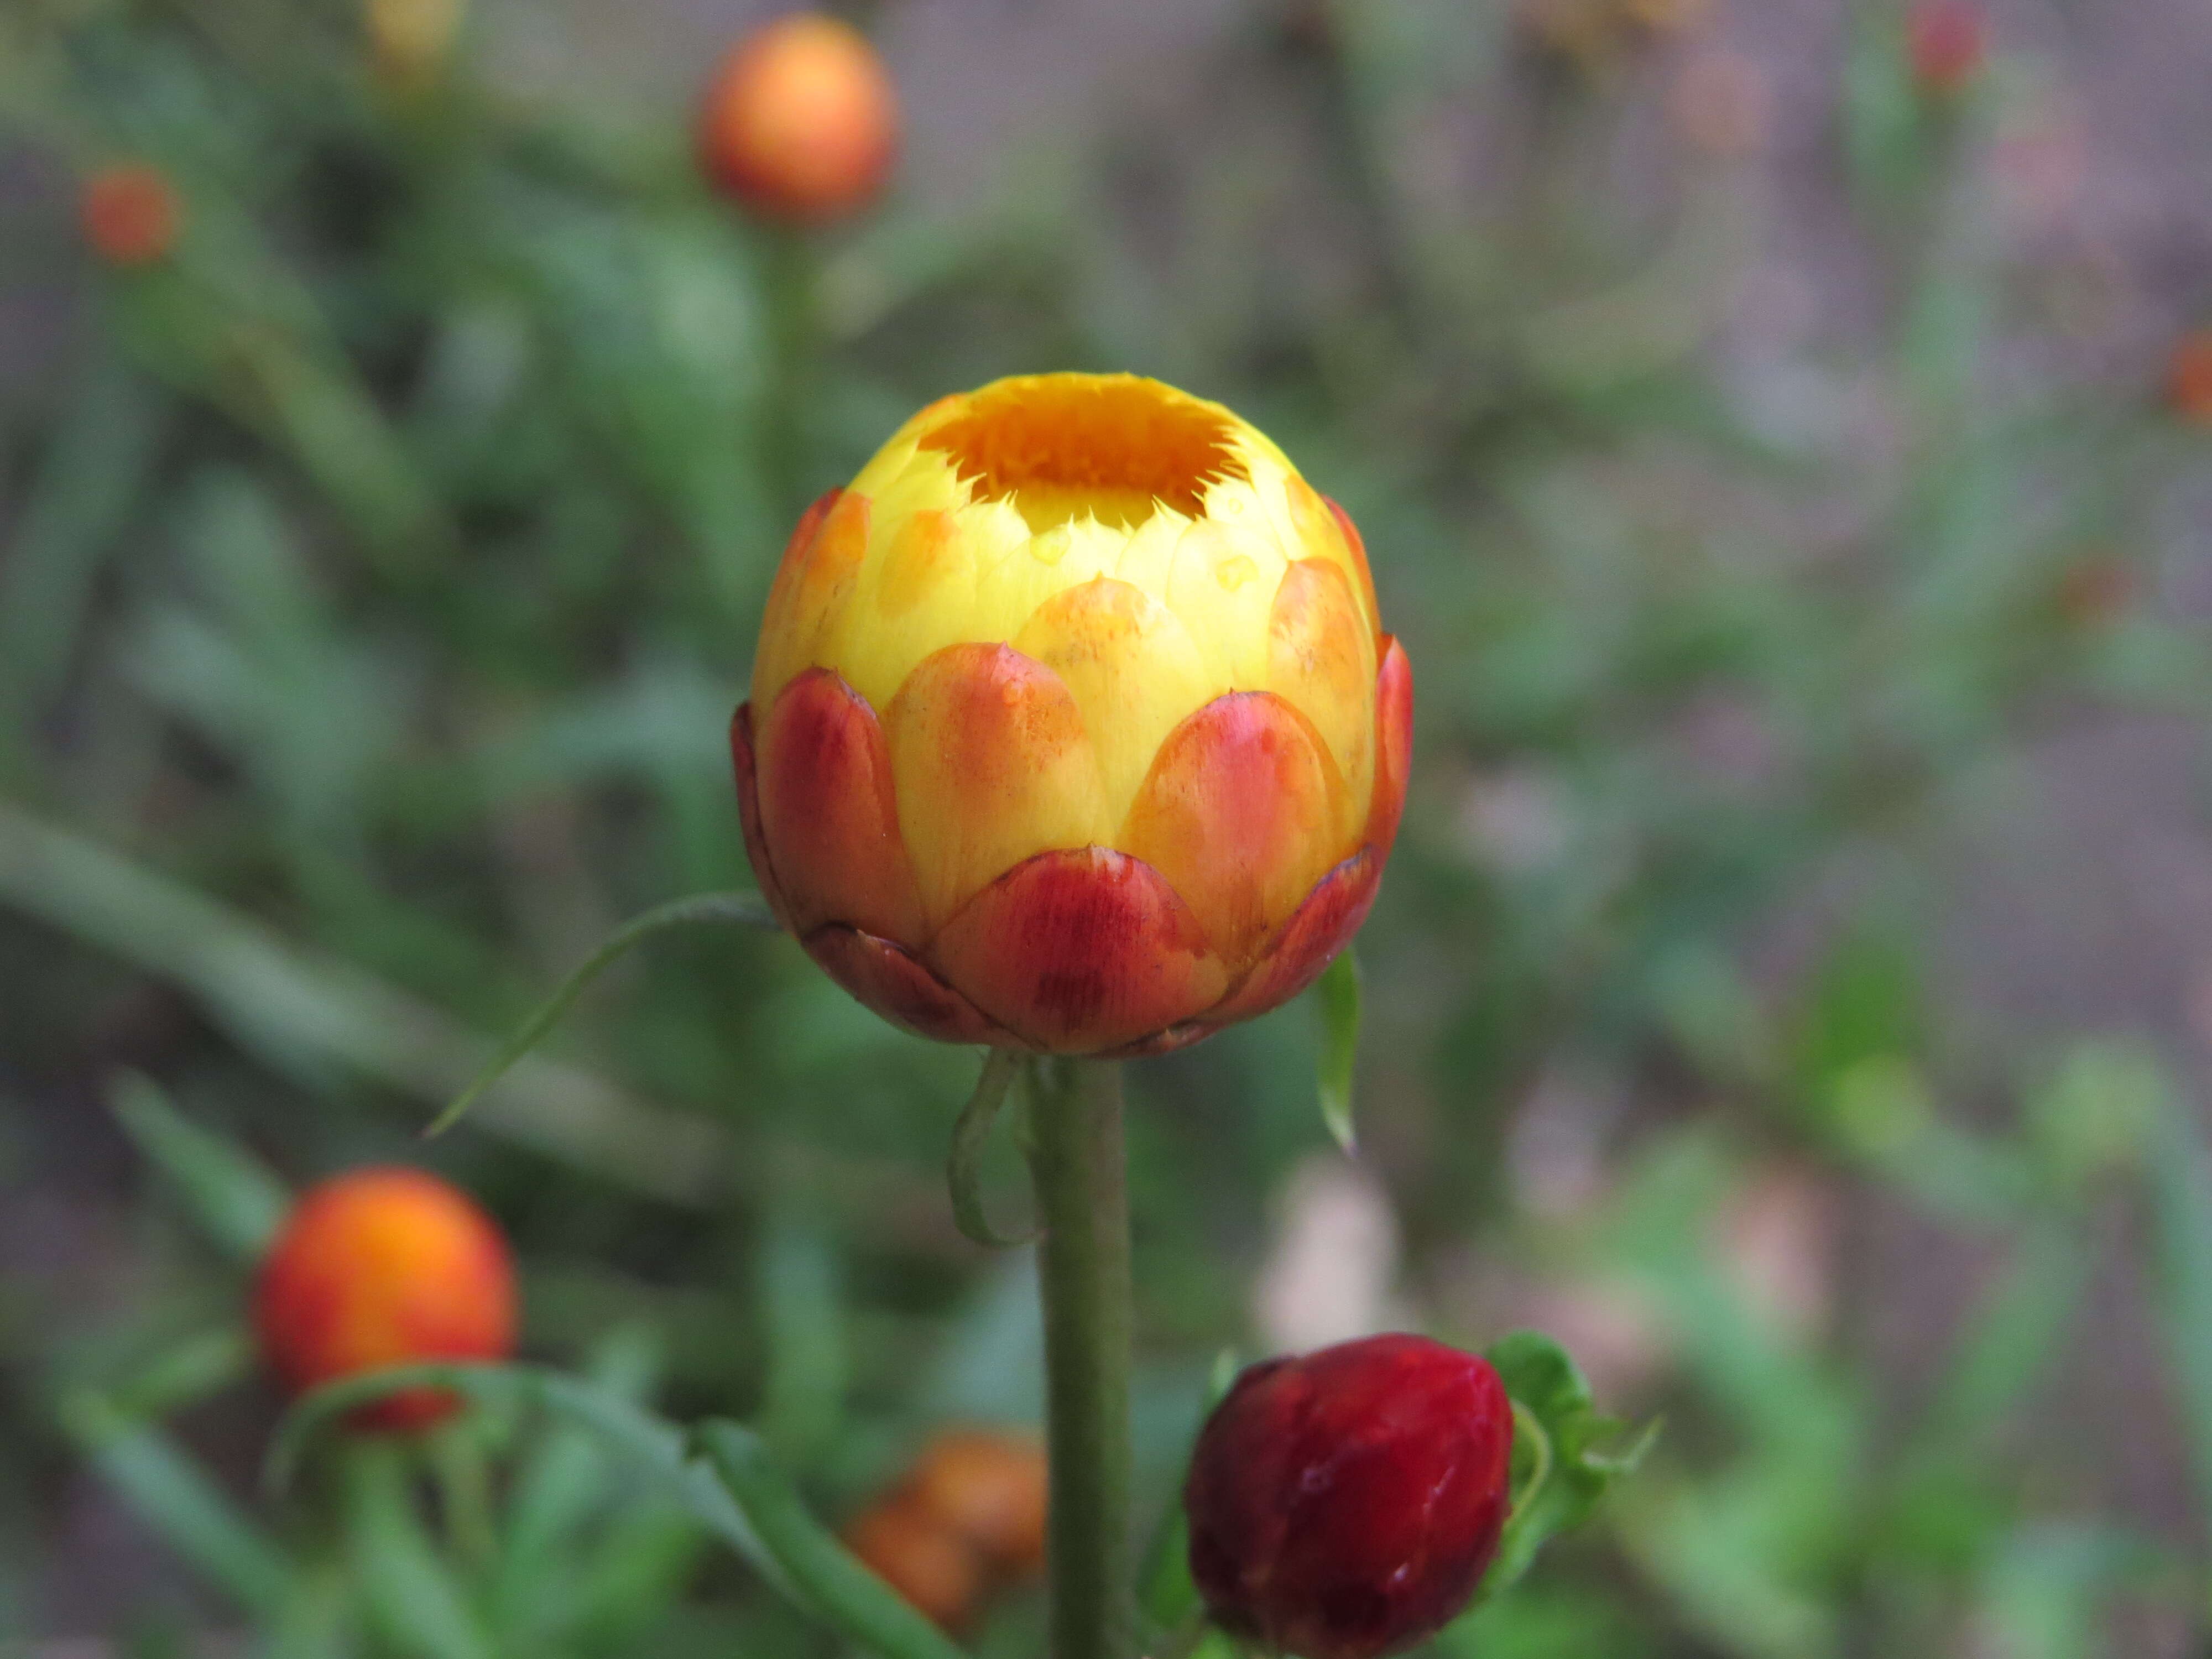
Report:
1013,575,1221,823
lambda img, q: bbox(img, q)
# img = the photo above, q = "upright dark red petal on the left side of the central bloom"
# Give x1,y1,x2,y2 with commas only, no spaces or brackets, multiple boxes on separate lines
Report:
759,668,925,947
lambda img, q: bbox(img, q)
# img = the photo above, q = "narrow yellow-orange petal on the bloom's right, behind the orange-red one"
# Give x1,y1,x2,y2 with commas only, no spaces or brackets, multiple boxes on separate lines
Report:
1267,560,1376,843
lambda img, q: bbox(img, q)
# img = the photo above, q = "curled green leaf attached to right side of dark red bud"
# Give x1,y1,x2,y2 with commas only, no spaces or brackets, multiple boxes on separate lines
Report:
1473,1332,1659,1606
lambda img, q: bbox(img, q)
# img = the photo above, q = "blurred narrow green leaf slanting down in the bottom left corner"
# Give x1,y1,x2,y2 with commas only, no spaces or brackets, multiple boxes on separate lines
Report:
62,1394,294,1617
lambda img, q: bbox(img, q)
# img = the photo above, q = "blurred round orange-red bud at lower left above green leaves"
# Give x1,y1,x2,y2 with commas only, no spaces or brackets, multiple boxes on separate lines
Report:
254,1168,515,1429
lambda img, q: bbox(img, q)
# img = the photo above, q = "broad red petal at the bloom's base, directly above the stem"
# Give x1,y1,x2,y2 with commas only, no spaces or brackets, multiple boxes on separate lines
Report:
929,847,1228,1053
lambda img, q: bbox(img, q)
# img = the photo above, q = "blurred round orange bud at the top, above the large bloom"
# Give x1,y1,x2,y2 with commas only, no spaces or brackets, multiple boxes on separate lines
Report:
699,11,898,223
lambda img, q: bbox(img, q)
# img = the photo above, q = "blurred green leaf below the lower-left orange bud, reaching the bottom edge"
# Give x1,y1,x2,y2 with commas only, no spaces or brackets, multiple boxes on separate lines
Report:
345,1436,493,1659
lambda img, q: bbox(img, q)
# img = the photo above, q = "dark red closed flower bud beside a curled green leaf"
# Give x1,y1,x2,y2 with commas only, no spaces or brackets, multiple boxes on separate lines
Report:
1183,1336,1513,1659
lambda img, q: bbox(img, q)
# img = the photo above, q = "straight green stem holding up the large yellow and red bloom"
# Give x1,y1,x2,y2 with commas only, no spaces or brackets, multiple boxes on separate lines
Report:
1029,1060,1137,1659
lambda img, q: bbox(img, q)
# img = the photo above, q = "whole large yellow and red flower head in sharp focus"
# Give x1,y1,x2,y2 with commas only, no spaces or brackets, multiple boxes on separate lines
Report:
730,374,1413,1053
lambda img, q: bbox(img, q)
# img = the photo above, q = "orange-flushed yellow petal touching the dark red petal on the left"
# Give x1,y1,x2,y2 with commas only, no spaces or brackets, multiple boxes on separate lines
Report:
883,644,1110,929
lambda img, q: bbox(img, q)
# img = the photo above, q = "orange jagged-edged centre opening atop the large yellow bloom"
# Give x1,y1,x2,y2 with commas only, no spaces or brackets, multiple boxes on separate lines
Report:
922,376,1248,531
